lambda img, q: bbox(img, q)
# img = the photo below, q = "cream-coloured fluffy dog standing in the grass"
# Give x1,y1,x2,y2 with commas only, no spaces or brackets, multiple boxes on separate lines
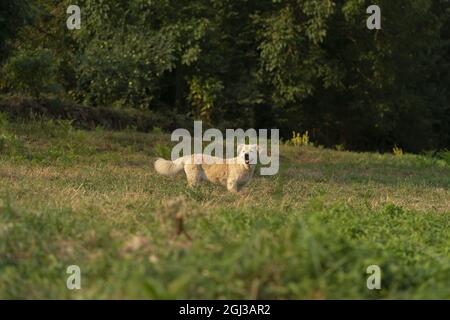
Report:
155,144,259,192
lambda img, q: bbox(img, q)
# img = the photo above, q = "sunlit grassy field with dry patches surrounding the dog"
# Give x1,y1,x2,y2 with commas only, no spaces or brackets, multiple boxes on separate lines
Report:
0,115,450,299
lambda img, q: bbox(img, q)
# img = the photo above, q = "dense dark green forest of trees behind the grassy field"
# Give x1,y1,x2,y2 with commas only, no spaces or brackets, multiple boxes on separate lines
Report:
0,0,450,152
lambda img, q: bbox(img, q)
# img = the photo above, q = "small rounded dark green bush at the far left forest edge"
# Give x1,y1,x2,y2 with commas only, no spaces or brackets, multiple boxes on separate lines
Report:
4,49,59,98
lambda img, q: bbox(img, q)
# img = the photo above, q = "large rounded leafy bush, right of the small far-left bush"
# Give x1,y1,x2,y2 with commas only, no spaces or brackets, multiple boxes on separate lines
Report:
76,24,175,109
